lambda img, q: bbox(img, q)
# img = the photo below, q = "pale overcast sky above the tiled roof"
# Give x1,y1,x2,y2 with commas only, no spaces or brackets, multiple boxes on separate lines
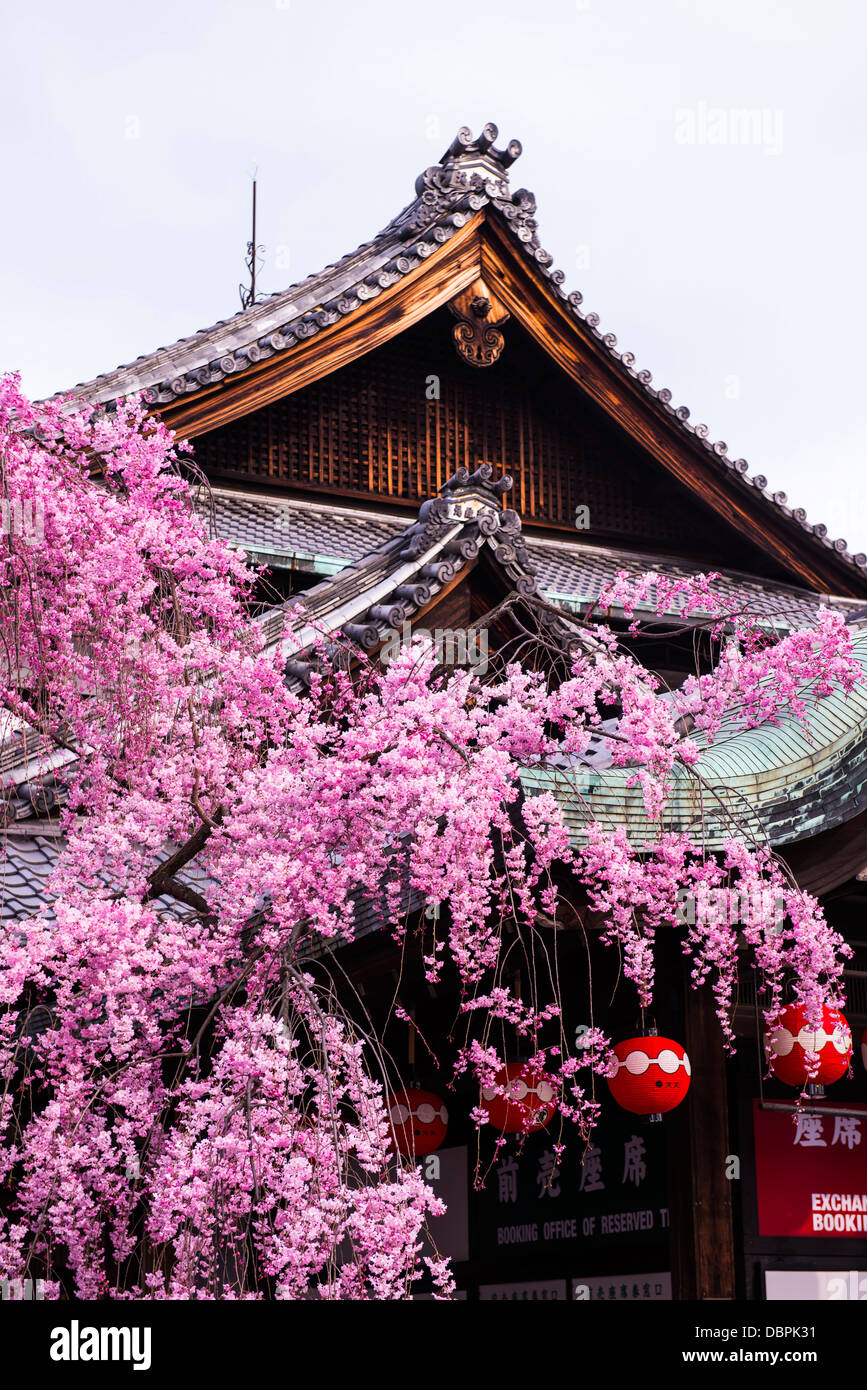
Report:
0,0,867,561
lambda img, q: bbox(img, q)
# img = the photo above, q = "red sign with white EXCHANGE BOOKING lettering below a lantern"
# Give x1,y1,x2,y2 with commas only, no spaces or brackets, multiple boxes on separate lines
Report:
753,1101,867,1240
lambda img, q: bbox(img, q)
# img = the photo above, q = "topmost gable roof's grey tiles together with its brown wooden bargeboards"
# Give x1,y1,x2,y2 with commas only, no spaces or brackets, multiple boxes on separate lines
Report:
59,124,867,595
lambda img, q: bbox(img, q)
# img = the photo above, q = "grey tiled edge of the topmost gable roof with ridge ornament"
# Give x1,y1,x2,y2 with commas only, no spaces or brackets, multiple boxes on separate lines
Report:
62,124,867,571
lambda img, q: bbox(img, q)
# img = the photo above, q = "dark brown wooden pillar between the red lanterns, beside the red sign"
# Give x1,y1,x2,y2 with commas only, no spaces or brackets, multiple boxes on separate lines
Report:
664,970,735,1298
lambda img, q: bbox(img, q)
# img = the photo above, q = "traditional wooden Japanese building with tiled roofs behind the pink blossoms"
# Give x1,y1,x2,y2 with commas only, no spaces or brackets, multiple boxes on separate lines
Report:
3,125,867,1300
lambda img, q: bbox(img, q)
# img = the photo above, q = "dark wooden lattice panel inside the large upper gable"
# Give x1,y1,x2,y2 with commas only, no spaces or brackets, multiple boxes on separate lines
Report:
195,310,756,569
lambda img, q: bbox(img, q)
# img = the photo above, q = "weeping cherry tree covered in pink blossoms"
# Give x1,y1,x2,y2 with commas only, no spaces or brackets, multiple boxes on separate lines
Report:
0,378,861,1300
